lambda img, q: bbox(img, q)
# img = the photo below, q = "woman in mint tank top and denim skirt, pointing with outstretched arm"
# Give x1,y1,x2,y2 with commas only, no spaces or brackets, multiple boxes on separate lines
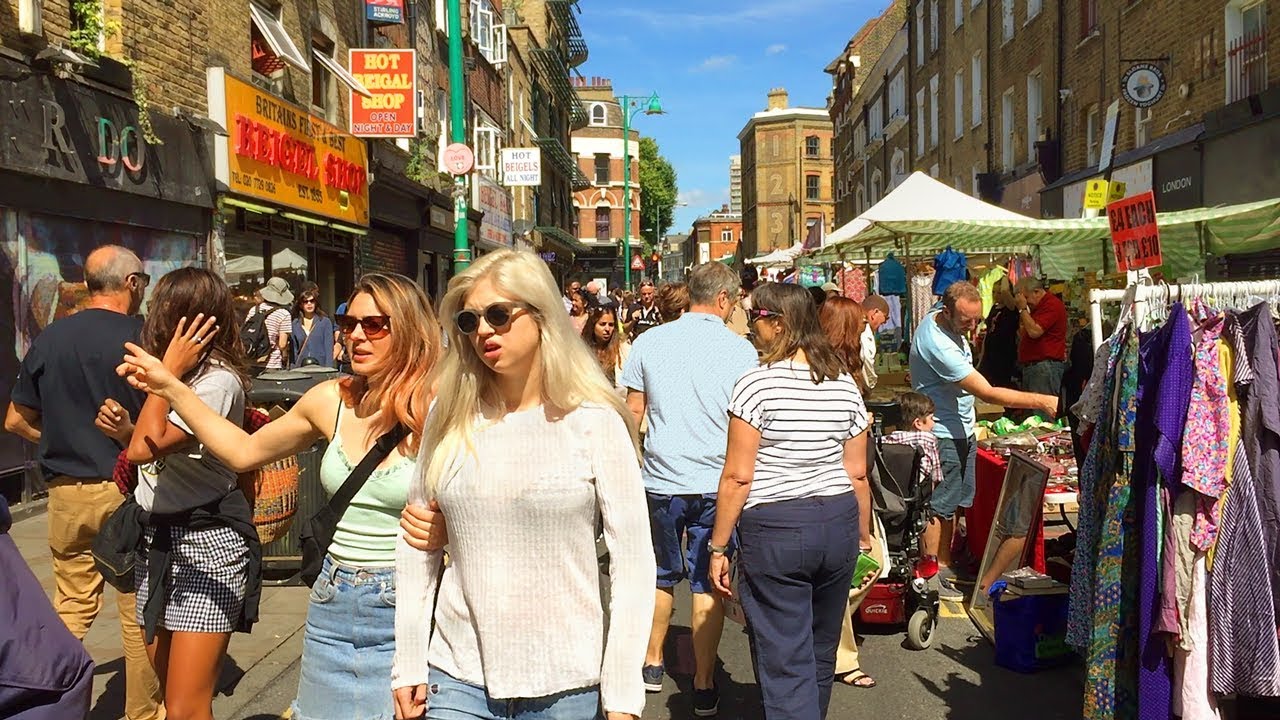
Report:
122,274,440,720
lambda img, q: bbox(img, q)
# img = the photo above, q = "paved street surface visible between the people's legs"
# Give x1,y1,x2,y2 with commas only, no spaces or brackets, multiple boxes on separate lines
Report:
13,504,1082,720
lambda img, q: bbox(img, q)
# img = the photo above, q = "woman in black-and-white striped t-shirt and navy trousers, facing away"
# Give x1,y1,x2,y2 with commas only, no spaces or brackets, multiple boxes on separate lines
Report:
710,283,870,720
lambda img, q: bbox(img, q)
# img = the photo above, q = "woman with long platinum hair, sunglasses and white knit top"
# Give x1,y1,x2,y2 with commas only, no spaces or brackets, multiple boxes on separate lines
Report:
392,251,655,720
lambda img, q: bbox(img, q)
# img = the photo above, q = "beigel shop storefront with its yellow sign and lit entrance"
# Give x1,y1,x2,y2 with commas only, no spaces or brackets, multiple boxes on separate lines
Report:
209,68,371,313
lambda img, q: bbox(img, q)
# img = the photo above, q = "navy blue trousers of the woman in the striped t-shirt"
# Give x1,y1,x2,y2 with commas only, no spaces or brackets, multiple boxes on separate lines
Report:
737,492,858,720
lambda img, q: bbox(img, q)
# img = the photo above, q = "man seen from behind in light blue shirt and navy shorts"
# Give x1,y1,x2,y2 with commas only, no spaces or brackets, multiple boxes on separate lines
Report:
622,263,759,716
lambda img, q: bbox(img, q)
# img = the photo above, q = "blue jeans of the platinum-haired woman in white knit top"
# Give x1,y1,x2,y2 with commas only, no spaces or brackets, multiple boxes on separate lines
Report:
426,667,604,720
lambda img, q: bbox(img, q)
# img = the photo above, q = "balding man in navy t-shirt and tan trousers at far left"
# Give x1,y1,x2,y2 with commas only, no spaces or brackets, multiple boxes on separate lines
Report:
4,245,164,720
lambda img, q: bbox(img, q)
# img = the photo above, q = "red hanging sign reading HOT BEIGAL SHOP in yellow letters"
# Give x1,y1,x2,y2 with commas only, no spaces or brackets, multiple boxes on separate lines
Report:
348,50,417,137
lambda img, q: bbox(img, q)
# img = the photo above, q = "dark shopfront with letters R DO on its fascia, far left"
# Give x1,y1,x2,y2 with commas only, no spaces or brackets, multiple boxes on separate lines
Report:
0,58,214,501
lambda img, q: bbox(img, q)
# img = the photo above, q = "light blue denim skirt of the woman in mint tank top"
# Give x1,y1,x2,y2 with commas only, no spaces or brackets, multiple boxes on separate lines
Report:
293,556,396,720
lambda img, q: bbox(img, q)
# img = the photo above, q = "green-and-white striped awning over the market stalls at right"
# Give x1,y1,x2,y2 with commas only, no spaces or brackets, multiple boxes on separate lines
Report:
814,199,1280,278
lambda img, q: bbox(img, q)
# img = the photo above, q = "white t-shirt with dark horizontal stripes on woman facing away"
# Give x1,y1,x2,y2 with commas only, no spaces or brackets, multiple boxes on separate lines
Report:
728,361,868,507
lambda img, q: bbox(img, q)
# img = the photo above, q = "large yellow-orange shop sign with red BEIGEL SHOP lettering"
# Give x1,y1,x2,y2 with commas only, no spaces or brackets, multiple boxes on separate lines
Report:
209,68,369,225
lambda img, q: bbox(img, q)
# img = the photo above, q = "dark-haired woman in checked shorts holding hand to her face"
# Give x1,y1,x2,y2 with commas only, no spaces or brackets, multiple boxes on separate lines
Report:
97,268,254,720
